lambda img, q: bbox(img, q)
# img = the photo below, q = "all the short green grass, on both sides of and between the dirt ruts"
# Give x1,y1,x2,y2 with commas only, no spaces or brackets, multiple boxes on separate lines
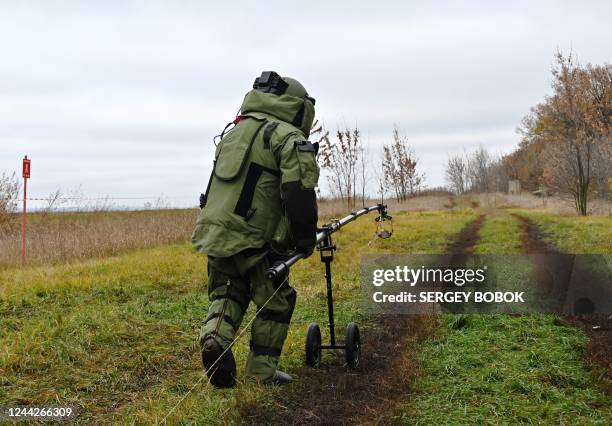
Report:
0,209,612,424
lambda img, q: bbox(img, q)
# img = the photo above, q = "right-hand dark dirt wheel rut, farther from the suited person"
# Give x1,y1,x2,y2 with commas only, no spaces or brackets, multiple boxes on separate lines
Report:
512,213,612,395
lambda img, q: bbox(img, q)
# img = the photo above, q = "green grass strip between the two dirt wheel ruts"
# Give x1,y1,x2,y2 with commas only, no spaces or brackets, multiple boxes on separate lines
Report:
398,212,612,425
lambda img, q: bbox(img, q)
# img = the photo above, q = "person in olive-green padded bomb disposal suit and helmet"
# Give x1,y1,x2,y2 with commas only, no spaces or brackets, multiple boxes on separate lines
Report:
192,71,319,387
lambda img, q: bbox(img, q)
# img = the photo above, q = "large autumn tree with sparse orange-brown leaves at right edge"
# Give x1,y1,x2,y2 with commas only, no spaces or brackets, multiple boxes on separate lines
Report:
519,52,612,215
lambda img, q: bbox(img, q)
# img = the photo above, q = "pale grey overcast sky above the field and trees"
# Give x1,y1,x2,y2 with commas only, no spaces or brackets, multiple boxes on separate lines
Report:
0,1,612,206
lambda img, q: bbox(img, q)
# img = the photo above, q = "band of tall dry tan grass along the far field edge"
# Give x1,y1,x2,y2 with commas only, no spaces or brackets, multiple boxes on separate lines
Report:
0,193,612,268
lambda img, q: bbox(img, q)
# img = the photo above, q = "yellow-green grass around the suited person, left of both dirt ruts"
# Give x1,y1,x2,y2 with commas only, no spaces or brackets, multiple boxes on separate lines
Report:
0,211,475,424
